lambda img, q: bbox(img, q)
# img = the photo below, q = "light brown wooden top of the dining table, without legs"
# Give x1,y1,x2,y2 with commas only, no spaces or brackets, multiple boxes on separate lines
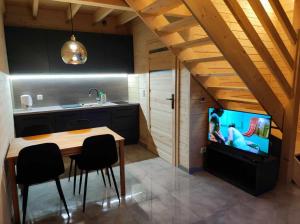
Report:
6,127,124,159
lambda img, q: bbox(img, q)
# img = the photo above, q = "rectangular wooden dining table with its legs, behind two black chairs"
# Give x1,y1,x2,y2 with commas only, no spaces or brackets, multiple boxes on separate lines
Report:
6,127,125,223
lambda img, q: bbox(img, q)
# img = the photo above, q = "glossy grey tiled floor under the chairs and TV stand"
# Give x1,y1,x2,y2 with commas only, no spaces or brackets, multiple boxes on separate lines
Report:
19,154,300,224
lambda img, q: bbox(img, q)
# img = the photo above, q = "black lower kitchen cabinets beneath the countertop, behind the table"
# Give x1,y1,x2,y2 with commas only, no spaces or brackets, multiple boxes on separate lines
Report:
14,105,139,144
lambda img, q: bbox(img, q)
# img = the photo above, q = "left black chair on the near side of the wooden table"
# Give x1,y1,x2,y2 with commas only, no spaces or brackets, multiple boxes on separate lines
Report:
16,143,70,223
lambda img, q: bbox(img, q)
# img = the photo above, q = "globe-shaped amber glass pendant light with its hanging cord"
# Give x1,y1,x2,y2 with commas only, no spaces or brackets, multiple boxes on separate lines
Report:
61,3,87,65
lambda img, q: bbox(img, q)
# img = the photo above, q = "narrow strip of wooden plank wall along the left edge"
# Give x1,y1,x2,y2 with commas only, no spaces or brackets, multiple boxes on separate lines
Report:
0,0,14,224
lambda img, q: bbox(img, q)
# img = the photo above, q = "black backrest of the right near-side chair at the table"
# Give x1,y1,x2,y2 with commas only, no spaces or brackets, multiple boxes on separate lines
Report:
78,135,118,170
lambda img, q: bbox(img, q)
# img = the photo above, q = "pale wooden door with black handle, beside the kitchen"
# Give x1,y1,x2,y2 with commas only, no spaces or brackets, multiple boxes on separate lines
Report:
149,52,176,164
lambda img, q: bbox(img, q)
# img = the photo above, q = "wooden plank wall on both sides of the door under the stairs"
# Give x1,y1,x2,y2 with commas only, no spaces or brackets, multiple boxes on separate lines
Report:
132,19,216,172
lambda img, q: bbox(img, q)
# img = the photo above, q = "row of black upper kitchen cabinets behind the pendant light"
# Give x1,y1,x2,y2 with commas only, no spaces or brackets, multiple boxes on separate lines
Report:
5,27,133,74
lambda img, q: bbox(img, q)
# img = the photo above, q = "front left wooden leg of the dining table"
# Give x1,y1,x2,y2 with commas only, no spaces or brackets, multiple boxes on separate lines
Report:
8,159,20,224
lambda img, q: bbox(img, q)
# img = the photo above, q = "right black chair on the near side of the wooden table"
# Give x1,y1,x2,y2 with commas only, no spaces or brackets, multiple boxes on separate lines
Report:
77,135,120,212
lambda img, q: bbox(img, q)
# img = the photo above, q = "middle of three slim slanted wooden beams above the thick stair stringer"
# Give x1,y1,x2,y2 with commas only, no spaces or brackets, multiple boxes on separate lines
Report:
248,0,294,70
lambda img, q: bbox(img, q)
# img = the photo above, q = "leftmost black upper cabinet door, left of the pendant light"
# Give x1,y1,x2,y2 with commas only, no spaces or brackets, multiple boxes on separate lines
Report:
5,27,49,74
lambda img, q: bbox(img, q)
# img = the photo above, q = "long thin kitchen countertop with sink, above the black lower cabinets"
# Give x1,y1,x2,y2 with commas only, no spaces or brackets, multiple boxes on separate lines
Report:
14,102,138,115
